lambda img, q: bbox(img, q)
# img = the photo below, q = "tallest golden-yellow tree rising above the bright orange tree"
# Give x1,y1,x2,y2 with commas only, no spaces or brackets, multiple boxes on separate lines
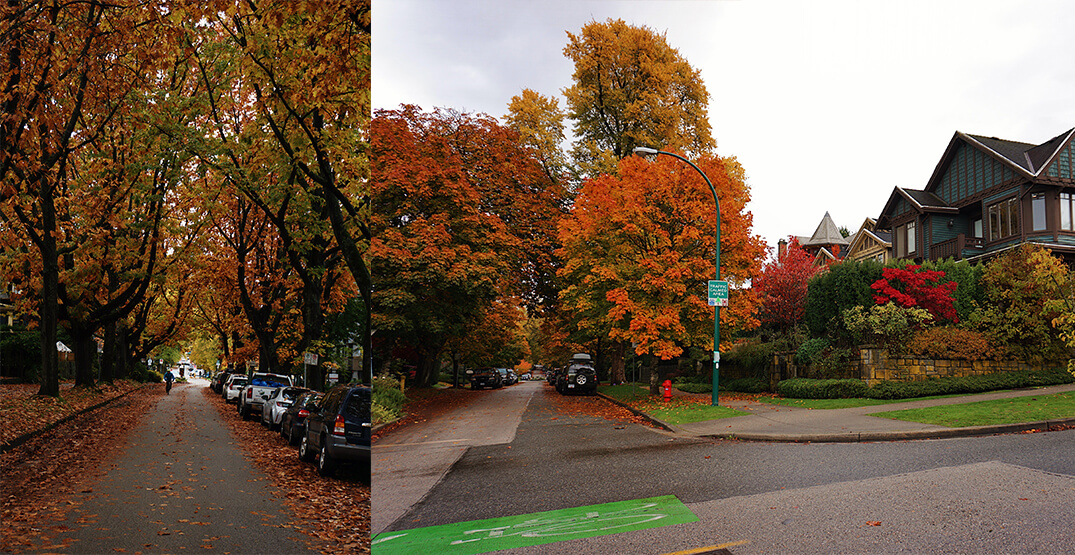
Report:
563,19,716,177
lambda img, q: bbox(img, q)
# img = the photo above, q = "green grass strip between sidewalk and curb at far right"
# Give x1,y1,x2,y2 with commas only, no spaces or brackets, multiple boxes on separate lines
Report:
872,392,1075,428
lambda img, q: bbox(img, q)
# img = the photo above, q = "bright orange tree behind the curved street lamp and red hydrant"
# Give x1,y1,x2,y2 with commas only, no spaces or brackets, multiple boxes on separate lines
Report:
558,155,764,381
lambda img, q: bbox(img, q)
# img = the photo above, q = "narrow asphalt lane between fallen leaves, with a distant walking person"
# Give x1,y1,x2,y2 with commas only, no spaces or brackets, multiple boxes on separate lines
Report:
46,384,319,554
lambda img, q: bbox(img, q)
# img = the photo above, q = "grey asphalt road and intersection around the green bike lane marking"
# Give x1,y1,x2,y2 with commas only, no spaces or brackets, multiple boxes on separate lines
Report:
374,384,1075,554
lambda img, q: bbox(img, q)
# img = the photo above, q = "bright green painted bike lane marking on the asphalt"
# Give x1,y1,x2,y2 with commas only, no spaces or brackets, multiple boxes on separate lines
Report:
371,495,699,555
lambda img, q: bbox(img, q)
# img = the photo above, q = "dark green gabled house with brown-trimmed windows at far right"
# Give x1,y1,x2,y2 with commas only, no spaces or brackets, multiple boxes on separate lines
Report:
876,128,1075,264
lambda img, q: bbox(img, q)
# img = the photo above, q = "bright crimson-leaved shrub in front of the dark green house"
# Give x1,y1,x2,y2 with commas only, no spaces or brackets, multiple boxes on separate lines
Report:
870,265,959,324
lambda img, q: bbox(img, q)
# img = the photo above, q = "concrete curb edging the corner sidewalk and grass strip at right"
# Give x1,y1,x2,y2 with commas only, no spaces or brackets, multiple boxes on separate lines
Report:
697,417,1075,443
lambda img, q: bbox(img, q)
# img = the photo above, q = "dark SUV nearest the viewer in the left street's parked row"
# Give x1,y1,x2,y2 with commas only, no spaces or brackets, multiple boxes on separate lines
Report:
299,385,373,475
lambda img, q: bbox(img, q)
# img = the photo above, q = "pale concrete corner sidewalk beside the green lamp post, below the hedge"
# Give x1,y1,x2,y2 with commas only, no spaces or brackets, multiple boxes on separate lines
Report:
669,384,1075,442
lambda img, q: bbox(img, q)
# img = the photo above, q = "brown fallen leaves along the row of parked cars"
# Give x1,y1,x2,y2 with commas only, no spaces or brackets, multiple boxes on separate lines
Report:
203,388,371,555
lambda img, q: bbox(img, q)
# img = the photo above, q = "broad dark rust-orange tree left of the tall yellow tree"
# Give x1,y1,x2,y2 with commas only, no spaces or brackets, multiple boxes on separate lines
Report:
370,106,563,385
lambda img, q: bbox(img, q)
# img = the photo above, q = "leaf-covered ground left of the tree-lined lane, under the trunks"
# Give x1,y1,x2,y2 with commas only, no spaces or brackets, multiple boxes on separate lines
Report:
0,380,146,450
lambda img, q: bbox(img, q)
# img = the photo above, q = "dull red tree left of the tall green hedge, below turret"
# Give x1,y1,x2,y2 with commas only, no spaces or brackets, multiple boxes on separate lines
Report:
753,238,820,331
